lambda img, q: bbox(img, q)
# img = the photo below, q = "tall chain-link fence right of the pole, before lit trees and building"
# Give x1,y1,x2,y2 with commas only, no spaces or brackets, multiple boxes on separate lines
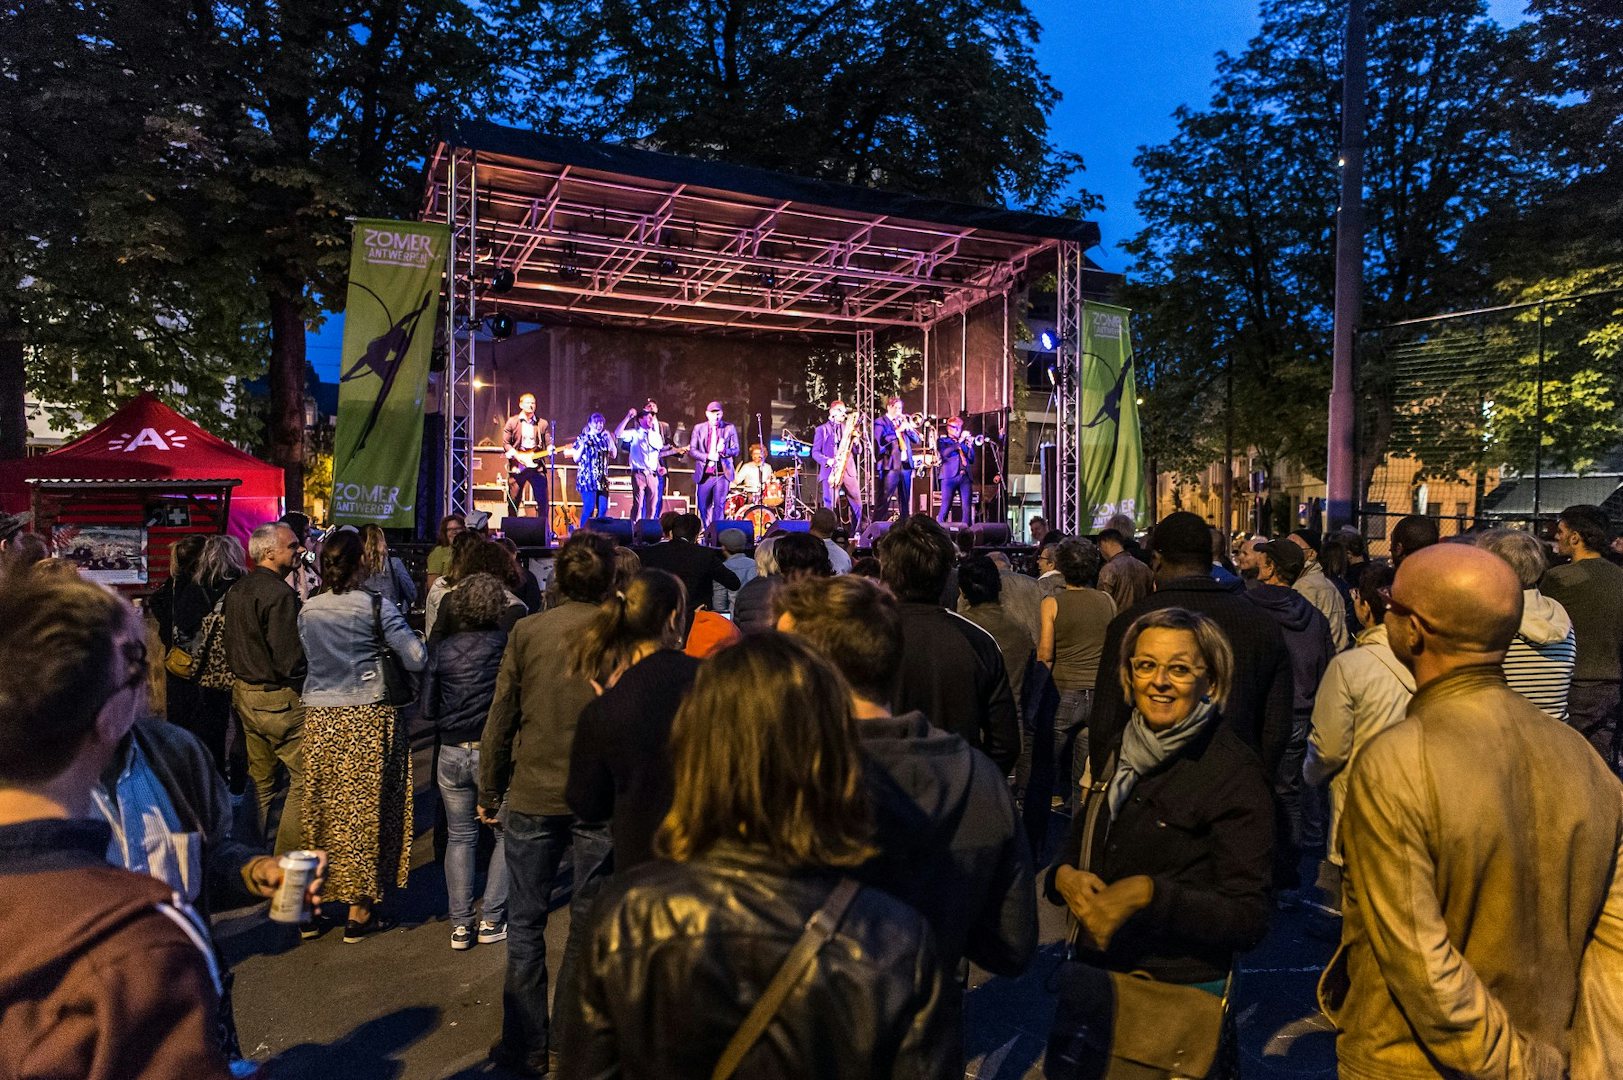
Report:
1358,289,1623,552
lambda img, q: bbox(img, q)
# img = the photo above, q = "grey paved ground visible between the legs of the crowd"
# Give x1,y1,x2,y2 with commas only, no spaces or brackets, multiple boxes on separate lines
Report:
216,737,1336,1080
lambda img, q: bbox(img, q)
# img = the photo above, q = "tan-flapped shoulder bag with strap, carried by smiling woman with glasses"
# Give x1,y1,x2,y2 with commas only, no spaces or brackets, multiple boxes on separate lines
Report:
1044,755,1229,1080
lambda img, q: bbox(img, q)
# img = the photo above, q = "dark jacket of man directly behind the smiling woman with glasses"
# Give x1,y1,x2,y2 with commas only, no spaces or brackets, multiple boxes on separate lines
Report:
1087,575,1294,776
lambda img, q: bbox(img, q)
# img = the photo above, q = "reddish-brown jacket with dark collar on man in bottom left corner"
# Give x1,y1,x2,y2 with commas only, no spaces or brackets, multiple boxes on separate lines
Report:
0,820,230,1080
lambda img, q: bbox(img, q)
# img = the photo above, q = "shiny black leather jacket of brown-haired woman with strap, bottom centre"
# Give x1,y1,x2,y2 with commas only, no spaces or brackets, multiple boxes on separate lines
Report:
558,845,964,1080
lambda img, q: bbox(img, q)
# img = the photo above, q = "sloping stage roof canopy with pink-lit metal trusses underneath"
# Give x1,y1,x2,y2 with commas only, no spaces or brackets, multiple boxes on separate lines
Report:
422,122,1099,336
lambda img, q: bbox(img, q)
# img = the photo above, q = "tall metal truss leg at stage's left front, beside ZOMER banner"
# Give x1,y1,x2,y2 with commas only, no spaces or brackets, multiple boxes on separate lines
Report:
441,149,479,515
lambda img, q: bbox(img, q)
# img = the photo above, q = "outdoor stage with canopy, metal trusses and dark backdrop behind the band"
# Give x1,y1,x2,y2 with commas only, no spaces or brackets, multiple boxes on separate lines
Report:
420,123,1099,531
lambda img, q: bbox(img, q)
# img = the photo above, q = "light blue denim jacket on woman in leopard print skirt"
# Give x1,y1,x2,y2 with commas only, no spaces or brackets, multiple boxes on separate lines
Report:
299,590,428,708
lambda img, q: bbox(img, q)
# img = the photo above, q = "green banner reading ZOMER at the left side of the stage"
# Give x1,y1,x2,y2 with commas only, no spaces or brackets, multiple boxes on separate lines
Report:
331,219,450,528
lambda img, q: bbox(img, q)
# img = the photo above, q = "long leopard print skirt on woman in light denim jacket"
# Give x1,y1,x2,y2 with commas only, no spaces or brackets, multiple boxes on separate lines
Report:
304,703,412,903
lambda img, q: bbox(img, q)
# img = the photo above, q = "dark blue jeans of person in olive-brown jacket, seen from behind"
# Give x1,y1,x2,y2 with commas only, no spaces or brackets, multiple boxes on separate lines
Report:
502,810,612,1067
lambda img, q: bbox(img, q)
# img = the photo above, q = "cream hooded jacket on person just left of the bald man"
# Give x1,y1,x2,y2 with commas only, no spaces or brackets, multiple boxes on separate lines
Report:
1302,625,1415,866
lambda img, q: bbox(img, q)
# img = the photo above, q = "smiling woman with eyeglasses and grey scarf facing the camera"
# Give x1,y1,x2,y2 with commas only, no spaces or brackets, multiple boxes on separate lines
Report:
1047,607,1274,1077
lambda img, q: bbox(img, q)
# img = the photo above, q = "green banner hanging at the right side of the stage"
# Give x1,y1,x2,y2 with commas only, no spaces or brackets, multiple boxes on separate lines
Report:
1081,300,1147,529
